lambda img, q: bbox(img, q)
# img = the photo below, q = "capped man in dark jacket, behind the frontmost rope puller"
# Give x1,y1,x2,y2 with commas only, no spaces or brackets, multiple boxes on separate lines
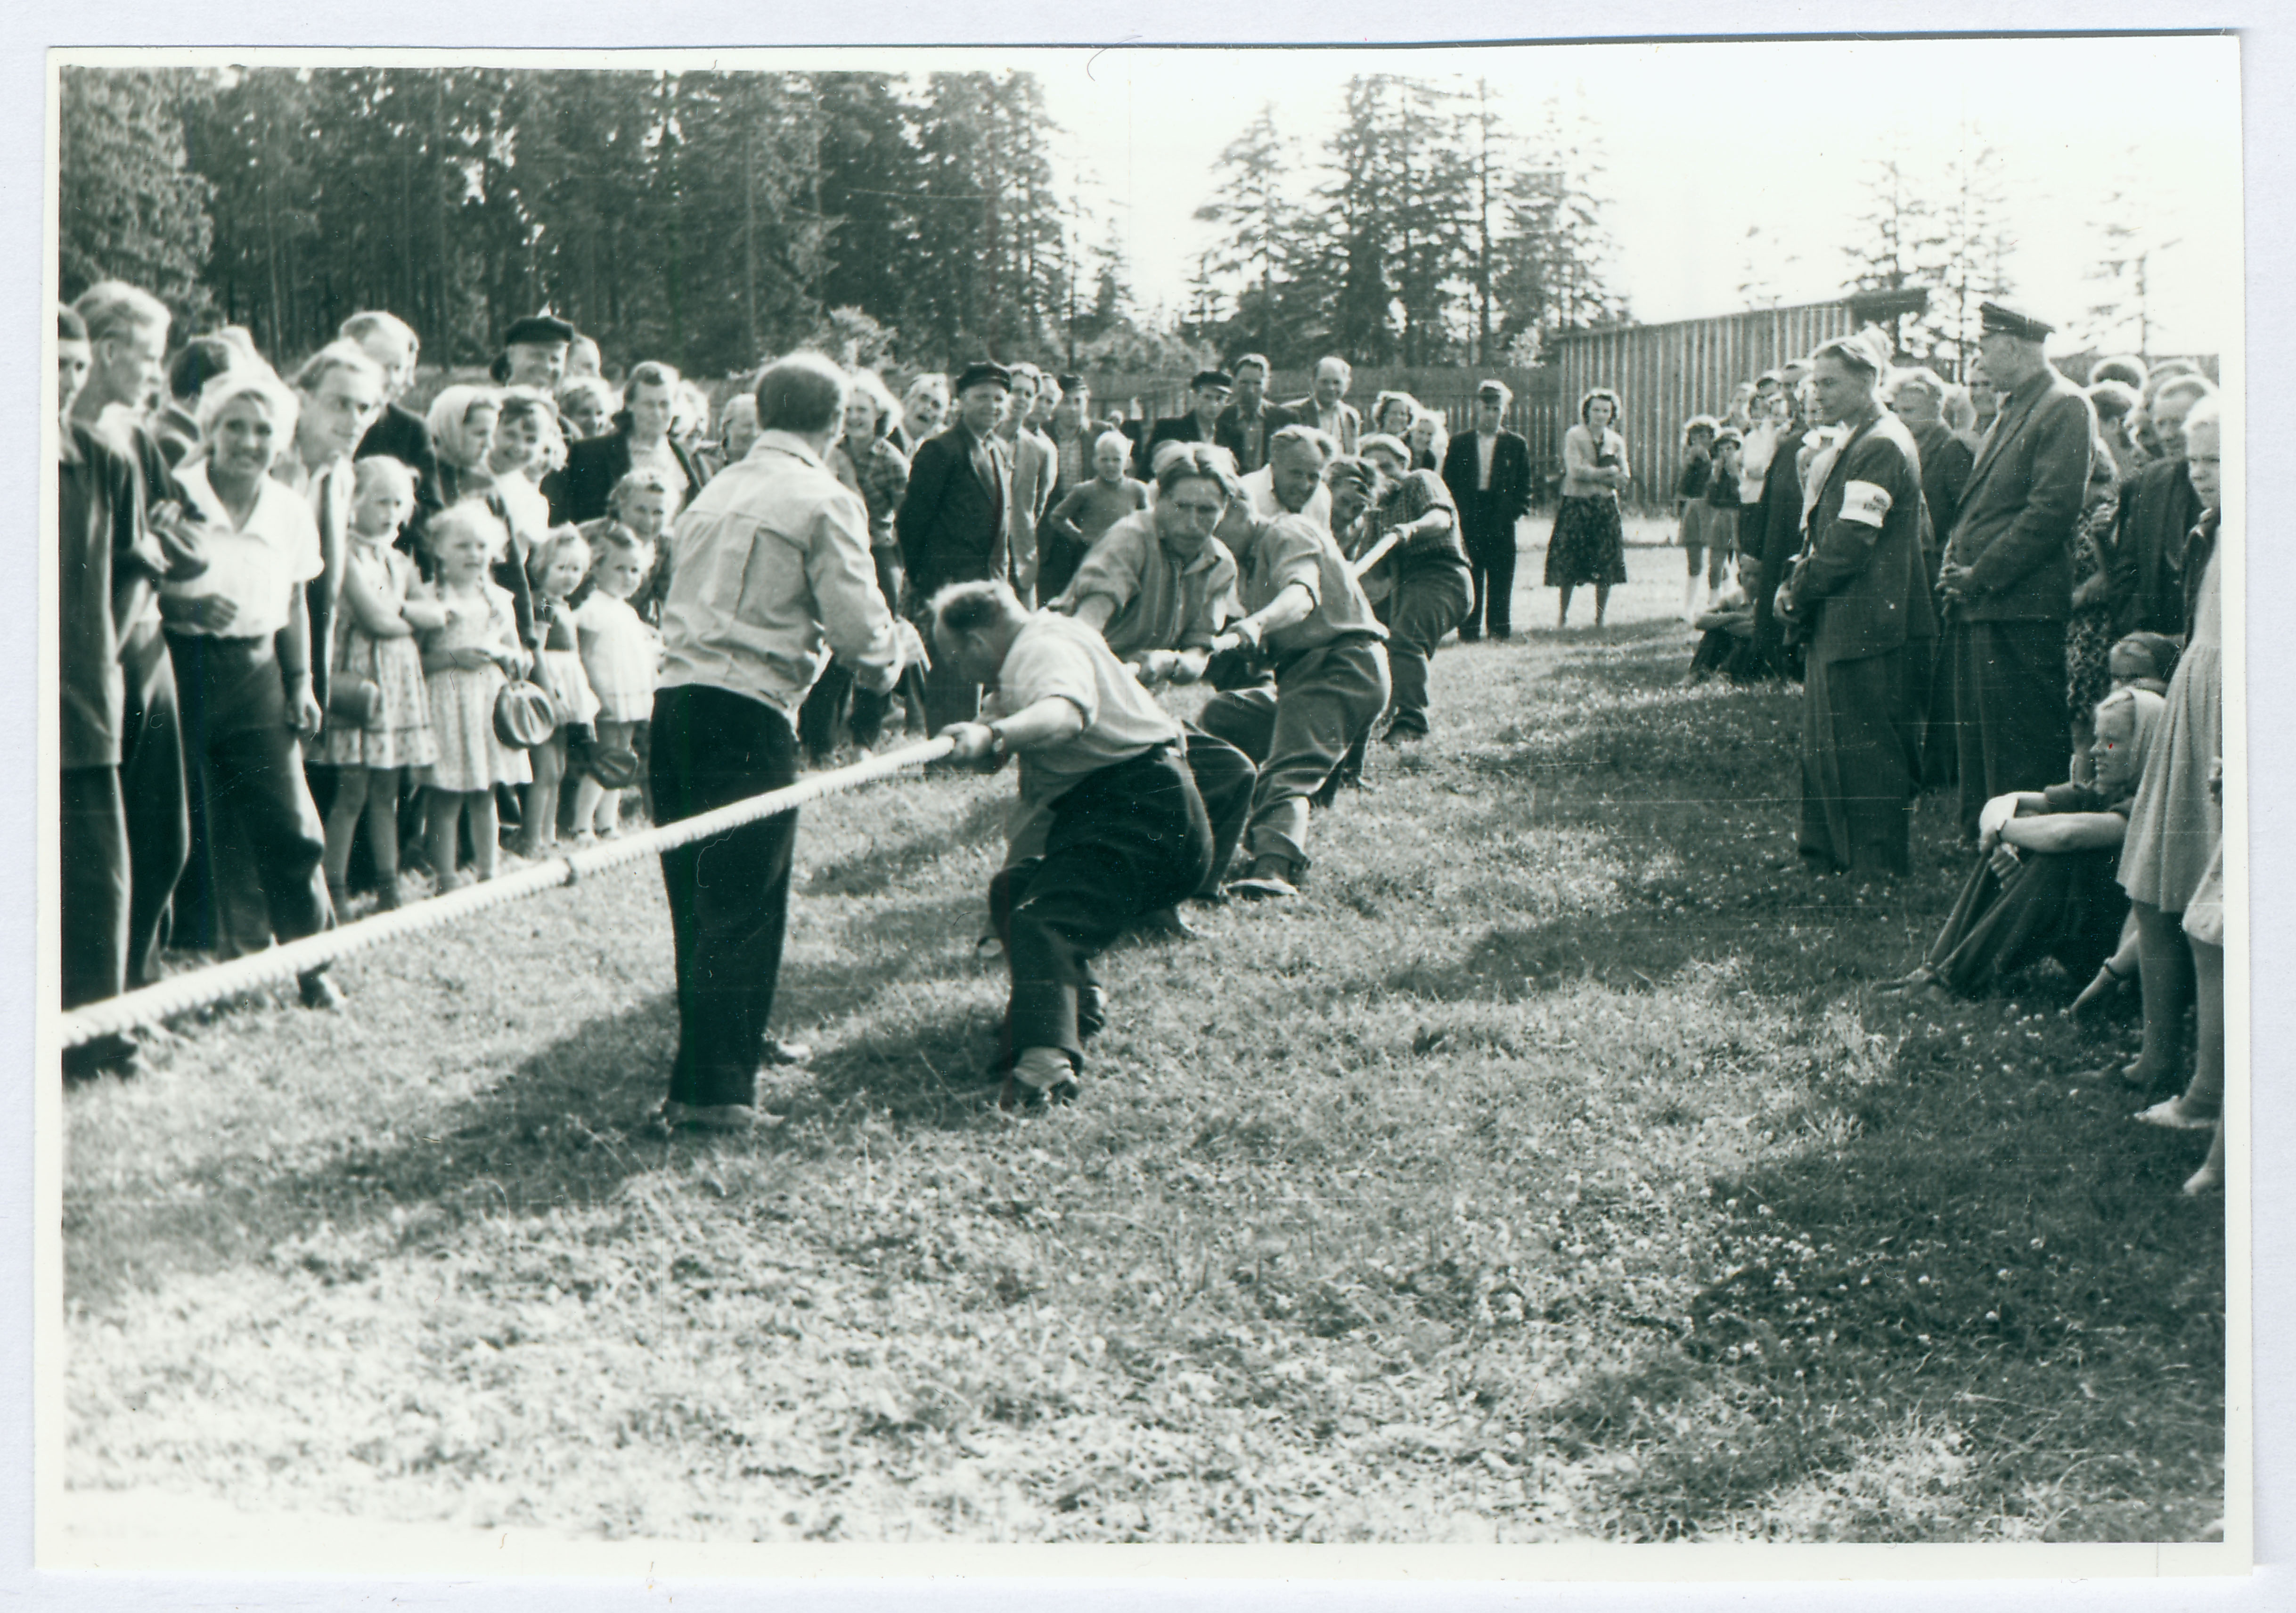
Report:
893,361,1017,733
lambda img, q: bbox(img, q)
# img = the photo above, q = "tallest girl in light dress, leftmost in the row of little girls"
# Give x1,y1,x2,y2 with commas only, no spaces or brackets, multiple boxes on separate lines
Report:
312,459,445,915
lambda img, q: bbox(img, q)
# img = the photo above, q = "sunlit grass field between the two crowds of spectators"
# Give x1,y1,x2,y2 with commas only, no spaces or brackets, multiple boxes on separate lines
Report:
64,538,2225,1542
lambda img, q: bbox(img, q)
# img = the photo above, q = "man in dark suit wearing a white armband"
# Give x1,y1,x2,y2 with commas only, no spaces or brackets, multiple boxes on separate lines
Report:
1777,331,1938,873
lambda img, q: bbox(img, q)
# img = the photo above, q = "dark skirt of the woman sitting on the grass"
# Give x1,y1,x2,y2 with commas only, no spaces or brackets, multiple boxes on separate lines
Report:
1926,850,2128,997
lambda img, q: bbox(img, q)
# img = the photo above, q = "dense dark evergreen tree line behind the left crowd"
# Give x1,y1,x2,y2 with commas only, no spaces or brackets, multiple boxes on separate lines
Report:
60,66,1128,375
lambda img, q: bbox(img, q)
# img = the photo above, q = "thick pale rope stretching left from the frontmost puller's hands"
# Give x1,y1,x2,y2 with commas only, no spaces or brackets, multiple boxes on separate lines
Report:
62,737,950,1048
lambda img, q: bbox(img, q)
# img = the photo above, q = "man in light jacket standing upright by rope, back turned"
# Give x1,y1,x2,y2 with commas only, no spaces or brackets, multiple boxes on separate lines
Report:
650,354,902,1130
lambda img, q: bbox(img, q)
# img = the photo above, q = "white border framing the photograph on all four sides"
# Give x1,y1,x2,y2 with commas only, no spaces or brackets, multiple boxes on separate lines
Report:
13,0,2296,1608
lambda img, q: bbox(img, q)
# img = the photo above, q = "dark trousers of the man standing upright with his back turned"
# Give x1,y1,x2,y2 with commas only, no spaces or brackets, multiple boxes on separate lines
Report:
650,685,797,1107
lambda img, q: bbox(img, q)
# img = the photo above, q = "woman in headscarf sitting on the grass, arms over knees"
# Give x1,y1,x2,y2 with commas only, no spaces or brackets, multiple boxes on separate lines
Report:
1896,689,2167,997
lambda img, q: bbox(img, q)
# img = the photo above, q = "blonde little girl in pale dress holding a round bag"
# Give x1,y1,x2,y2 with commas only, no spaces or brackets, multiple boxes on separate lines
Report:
423,503,533,894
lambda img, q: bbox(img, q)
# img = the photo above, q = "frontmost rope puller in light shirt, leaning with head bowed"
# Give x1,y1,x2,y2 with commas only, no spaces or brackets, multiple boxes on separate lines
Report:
932,581,1212,1107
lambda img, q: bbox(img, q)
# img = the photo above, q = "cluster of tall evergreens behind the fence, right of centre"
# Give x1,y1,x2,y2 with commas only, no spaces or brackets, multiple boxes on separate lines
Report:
1183,74,1628,368
